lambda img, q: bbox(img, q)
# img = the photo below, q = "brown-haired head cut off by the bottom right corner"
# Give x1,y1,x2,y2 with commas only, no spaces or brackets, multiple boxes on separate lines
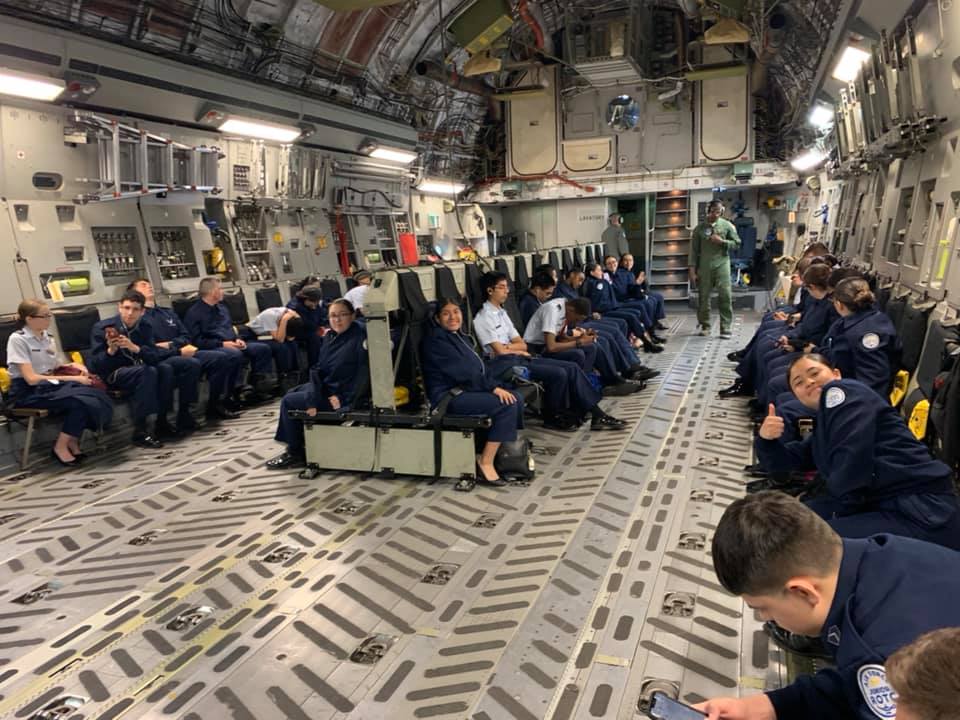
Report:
885,627,960,720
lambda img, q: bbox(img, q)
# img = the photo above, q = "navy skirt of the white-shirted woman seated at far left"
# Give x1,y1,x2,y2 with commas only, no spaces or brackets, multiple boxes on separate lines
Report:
10,378,113,438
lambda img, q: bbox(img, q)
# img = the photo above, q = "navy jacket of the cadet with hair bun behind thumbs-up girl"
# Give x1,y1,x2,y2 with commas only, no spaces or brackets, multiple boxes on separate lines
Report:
807,301,900,395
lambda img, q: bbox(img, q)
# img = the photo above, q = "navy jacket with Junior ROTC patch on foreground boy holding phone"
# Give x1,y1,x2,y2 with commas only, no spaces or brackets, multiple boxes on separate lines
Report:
767,535,960,720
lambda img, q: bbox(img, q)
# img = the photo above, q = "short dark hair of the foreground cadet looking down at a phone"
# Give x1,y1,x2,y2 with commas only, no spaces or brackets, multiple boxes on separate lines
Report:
712,490,843,595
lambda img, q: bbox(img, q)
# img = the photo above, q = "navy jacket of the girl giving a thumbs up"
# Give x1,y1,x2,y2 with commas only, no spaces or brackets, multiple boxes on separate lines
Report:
758,379,953,510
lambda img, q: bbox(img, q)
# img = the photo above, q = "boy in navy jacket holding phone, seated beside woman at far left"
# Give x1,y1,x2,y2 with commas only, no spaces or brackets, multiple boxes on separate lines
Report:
90,290,184,448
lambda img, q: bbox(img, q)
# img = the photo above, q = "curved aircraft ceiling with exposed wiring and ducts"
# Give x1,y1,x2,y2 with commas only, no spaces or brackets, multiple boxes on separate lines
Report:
0,0,870,173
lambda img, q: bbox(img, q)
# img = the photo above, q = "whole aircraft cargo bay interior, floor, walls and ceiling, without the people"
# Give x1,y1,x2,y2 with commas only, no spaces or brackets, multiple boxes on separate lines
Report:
0,0,960,720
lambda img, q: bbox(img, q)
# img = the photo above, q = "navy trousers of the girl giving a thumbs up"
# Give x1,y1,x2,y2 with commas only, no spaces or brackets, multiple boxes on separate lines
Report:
805,495,960,550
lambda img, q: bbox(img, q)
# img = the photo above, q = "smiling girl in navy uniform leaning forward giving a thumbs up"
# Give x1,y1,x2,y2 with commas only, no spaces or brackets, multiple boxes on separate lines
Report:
758,354,960,550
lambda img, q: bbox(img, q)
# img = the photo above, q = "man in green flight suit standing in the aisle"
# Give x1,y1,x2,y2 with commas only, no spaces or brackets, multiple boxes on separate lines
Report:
688,200,740,339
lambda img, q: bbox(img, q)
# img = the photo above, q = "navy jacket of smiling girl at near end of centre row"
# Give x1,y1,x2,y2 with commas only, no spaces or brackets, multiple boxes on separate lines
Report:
421,325,499,407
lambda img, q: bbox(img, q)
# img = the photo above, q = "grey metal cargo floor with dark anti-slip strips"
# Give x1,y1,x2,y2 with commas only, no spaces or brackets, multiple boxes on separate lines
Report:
0,315,782,720
